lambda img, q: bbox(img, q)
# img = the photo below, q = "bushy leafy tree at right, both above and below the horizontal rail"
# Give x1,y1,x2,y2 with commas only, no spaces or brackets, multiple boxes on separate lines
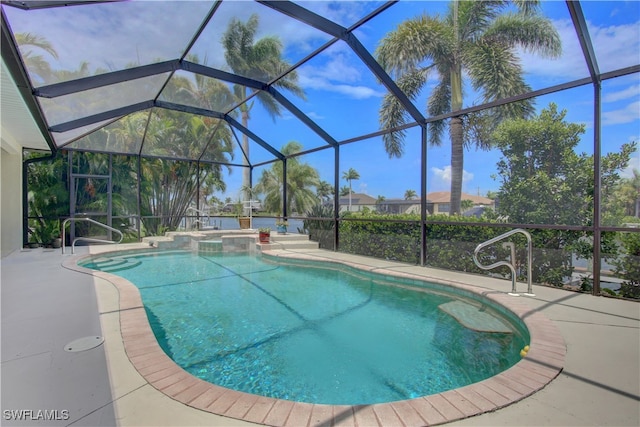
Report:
493,103,636,286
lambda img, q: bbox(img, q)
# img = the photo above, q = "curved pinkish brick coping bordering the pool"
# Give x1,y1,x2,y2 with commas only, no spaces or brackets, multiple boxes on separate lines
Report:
63,250,566,427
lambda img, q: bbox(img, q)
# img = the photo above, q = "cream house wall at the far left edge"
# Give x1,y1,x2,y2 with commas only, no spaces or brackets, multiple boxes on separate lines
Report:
0,144,22,258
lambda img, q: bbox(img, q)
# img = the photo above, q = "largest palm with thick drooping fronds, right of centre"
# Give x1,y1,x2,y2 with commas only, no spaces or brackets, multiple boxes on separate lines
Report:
376,0,561,214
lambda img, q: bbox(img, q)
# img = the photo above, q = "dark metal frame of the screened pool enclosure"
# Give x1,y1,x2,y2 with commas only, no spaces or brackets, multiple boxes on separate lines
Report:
2,0,640,295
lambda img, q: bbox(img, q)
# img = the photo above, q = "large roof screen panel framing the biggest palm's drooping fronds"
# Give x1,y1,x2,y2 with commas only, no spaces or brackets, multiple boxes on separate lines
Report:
356,1,589,116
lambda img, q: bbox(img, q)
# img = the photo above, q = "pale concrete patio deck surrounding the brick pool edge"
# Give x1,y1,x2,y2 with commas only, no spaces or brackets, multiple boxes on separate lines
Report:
1,245,640,426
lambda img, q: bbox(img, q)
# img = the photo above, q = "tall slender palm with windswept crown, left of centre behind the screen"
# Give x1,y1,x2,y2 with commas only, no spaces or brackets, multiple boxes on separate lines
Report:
222,14,304,201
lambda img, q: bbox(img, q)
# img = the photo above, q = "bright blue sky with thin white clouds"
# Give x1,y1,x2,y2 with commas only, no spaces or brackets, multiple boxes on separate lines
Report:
3,0,640,204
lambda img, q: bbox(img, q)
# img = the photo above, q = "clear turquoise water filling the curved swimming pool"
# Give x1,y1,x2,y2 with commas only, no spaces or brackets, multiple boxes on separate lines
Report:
82,252,528,405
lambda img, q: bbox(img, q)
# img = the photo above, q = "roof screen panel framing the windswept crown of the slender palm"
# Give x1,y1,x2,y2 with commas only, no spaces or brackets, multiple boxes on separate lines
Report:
189,1,331,83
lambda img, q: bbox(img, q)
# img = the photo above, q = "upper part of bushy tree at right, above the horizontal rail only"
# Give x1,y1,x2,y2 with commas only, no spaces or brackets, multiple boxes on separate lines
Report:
494,103,636,226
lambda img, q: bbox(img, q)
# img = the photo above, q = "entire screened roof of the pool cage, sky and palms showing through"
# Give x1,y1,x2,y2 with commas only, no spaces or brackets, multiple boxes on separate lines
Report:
2,0,640,169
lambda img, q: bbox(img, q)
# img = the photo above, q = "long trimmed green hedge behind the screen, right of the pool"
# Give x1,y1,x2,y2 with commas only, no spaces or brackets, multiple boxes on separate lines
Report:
339,212,584,286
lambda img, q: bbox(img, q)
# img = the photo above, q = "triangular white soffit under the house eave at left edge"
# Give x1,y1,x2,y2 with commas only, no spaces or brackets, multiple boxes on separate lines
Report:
0,60,50,154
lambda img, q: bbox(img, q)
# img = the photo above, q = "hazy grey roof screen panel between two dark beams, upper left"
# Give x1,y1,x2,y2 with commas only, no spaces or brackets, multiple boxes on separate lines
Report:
39,73,169,126
